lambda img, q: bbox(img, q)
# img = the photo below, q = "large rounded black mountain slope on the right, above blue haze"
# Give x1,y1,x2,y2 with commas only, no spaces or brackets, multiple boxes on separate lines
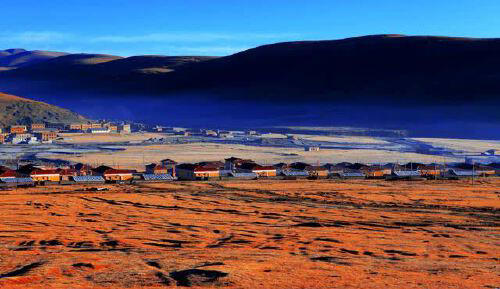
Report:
158,35,500,103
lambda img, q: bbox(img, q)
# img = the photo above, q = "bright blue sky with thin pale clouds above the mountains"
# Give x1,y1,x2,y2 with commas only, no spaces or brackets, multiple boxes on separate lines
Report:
0,0,500,56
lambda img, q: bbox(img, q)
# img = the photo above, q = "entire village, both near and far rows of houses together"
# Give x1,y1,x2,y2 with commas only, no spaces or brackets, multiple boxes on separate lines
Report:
0,120,500,188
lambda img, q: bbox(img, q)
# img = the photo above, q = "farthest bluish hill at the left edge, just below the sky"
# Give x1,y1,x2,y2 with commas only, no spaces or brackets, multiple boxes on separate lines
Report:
0,48,67,70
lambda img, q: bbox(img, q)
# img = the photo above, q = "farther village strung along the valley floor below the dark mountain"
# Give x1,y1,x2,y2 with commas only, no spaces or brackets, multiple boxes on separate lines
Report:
0,120,401,146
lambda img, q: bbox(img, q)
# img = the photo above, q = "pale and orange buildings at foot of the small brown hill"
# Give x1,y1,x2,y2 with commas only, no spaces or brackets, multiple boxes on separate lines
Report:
0,122,131,144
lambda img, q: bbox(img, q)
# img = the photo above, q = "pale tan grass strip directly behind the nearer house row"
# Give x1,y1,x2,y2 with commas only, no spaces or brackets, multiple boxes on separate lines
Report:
43,143,458,170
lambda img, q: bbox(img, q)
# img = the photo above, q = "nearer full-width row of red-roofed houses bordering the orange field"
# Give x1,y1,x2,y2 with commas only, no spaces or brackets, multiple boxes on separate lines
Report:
0,157,500,187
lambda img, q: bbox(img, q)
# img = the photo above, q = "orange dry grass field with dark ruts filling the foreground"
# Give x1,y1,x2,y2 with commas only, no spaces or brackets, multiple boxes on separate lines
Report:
0,179,500,288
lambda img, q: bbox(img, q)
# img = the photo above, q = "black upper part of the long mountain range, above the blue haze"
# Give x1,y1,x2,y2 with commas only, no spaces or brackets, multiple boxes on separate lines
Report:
0,35,500,103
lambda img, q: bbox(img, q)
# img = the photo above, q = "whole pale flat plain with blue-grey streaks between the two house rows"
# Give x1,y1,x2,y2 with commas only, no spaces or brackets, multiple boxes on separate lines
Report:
38,133,488,170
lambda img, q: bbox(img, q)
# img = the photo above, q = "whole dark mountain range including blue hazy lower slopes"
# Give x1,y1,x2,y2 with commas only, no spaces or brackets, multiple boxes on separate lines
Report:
0,35,500,136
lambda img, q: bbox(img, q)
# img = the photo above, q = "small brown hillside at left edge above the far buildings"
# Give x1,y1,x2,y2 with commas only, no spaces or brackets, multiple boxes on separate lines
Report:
0,92,85,127
